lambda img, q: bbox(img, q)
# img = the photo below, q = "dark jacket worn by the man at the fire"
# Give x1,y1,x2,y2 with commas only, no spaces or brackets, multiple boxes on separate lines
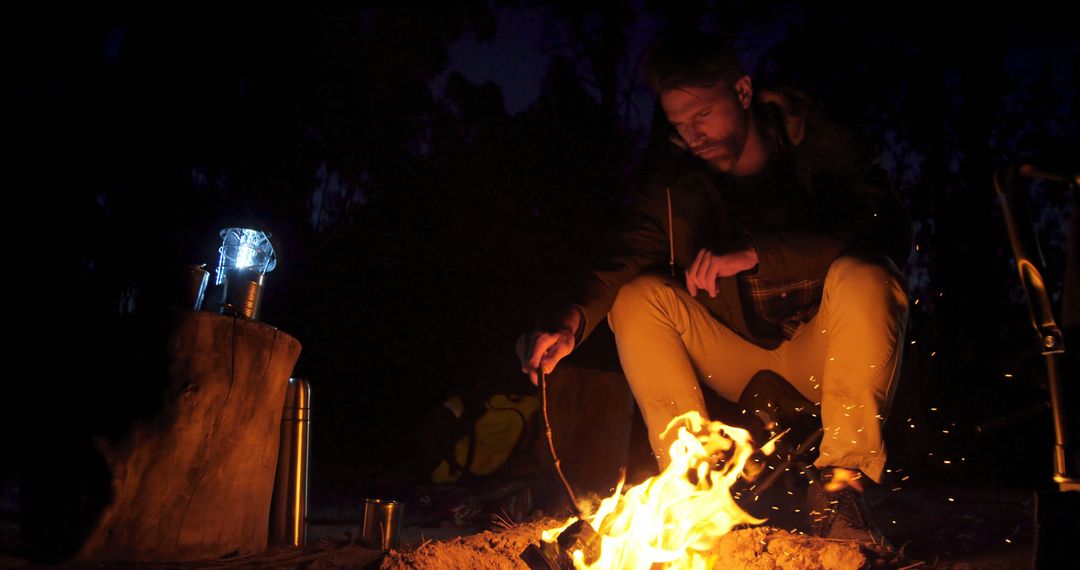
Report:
565,90,912,349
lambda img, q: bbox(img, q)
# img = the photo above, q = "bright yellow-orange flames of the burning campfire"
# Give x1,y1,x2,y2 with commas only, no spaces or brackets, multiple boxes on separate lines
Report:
541,411,773,569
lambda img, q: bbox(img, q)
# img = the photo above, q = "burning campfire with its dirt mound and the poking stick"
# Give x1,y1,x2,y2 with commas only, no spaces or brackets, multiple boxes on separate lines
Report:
380,374,906,570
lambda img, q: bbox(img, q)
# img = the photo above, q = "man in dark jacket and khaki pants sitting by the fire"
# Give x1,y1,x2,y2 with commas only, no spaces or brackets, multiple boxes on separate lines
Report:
518,35,912,542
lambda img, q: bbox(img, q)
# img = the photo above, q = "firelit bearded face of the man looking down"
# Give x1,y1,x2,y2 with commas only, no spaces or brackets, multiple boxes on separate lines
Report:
660,76,750,173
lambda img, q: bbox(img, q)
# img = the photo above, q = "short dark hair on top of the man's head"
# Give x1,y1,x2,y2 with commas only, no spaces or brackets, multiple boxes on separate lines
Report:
645,31,746,93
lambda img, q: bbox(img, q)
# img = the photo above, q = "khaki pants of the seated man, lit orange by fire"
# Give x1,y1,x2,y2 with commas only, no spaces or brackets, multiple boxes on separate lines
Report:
608,256,908,483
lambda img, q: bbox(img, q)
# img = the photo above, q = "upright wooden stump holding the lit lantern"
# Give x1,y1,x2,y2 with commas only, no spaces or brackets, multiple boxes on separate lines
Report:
77,311,300,561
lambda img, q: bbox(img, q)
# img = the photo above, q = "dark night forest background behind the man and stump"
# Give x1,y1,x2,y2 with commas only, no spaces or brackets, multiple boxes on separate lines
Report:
10,0,1080,557
